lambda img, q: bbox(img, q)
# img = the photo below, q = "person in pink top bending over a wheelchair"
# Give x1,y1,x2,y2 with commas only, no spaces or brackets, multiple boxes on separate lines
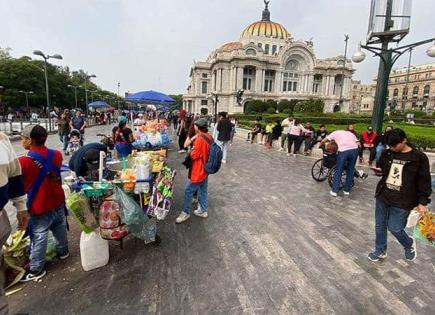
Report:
322,130,359,197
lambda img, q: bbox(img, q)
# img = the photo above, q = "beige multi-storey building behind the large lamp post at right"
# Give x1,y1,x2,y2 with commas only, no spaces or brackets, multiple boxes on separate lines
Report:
352,63,435,113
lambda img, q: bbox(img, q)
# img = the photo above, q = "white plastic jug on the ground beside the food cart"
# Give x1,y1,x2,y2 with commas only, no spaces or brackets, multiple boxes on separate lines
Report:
80,230,109,271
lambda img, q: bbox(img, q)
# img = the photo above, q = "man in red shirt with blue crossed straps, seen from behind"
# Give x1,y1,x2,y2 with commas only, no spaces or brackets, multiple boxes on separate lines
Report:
19,125,69,282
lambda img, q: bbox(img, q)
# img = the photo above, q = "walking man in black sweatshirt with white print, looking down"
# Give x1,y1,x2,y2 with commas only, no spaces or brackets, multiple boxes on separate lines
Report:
368,129,432,261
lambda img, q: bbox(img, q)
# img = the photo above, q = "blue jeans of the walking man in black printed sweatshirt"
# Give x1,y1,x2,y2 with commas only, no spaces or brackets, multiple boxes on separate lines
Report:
375,198,413,254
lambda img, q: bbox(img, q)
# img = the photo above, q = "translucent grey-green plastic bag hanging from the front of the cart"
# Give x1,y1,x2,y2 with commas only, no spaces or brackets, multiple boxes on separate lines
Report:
115,186,156,242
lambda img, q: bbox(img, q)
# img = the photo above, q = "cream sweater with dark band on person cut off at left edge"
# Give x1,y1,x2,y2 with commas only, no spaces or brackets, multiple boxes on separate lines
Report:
0,132,27,211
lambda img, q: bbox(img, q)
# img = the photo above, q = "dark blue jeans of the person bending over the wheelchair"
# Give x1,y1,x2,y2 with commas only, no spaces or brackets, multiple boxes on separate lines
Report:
332,149,358,193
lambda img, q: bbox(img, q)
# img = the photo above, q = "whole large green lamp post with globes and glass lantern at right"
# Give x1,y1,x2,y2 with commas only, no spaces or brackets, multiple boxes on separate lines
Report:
352,0,435,133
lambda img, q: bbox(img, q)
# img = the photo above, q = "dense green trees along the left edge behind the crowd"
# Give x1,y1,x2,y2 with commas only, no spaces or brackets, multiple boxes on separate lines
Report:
0,52,117,111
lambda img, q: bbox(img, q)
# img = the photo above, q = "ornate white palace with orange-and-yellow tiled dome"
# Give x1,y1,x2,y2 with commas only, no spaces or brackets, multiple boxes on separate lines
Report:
183,1,353,114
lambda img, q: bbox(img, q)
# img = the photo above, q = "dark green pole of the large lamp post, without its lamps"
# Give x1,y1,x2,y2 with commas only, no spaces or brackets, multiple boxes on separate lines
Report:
372,0,393,134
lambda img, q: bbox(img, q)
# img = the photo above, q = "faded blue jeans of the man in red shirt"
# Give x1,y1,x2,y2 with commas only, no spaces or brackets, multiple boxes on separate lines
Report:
30,204,68,272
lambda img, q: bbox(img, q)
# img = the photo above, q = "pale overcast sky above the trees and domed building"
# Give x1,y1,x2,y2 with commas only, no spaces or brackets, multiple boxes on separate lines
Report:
0,0,435,94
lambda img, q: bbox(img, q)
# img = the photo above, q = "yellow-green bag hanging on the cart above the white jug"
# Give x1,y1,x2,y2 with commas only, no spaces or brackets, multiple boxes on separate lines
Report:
66,193,98,233
